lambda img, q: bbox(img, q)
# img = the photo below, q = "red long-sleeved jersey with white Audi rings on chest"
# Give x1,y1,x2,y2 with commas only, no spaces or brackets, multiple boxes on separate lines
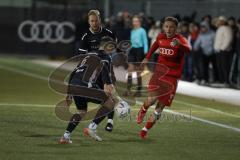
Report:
146,33,190,78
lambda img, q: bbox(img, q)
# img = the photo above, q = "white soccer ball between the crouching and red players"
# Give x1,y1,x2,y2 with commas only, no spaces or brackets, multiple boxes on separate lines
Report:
115,100,131,118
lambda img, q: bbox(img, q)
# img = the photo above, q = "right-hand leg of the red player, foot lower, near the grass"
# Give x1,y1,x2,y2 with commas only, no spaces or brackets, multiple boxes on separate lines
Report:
139,102,165,139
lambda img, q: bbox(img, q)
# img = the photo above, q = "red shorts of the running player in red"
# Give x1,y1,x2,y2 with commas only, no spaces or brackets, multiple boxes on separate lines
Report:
148,73,178,106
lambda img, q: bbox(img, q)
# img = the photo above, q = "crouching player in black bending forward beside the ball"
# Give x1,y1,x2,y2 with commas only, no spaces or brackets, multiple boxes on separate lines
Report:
59,37,118,144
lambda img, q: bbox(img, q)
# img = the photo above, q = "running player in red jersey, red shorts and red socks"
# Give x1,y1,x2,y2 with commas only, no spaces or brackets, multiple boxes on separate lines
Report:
137,17,190,139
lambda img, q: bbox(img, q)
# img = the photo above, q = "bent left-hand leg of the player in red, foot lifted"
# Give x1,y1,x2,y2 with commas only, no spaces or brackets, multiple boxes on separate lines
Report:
137,97,157,124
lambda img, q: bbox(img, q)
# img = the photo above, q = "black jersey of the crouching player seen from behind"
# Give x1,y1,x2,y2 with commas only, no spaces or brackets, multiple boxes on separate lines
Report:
69,51,112,88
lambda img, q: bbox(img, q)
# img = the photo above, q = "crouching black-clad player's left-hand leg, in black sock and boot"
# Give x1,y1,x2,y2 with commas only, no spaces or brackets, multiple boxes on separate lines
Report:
59,96,87,144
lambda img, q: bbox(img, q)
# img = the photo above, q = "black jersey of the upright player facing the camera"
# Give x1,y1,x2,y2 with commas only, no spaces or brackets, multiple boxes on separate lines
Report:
78,28,117,54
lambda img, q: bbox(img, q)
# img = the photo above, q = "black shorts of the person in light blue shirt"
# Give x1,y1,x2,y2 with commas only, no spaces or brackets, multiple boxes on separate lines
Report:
128,47,145,64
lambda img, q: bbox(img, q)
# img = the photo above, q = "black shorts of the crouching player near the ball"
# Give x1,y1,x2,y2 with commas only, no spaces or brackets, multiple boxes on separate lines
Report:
69,79,103,110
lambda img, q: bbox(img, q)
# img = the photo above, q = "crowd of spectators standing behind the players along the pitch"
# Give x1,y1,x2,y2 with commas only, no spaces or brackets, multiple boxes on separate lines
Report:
75,12,240,88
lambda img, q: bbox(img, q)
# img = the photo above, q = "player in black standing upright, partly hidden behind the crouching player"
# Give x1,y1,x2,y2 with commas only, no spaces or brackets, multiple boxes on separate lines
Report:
78,10,117,132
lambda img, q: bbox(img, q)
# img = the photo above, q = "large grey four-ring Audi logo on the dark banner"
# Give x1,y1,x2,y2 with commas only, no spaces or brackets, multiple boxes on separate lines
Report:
18,20,75,43
